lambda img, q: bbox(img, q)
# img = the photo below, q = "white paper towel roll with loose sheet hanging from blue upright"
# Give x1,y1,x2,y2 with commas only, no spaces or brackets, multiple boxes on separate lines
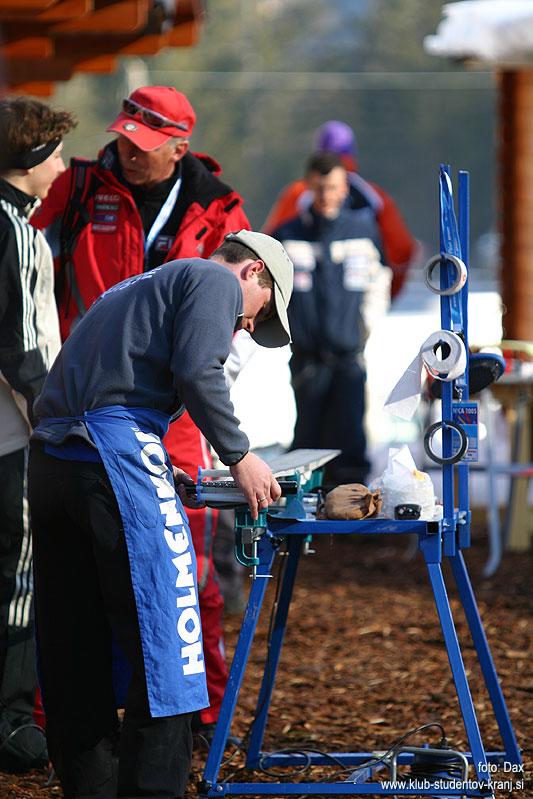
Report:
385,330,466,421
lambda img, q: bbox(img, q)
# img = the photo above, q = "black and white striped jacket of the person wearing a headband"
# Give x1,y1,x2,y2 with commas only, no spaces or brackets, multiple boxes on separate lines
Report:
0,179,61,457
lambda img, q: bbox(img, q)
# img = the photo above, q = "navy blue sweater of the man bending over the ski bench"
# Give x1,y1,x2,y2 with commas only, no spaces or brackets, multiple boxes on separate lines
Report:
35,258,249,464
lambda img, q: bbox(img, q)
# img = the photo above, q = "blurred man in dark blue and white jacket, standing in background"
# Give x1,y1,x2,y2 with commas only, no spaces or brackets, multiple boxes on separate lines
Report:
272,152,391,485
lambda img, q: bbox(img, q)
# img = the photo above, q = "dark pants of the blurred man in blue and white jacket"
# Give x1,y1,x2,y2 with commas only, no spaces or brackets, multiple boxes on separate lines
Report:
290,352,369,484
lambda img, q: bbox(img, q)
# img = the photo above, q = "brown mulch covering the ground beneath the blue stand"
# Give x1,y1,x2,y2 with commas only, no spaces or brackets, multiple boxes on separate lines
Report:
0,531,533,799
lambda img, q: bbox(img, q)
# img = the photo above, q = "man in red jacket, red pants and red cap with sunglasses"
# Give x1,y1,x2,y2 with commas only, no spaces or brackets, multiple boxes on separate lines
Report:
32,86,250,731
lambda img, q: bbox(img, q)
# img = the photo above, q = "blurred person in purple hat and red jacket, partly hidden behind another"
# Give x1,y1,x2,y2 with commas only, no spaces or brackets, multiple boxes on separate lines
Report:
263,120,418,299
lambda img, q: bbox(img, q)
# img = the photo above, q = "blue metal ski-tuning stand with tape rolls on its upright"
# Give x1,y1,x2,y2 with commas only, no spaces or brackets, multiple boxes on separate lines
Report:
201,166,521,797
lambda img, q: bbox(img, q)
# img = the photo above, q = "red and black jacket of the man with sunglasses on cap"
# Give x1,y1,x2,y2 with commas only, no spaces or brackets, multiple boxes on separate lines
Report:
32,142,250,339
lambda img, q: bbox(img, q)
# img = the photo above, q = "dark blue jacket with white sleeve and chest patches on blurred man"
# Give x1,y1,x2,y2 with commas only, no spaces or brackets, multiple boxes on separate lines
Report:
272,209,385,355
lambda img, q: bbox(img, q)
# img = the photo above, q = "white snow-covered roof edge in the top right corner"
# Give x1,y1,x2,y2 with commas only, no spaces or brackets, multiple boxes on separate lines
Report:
424,0,533,64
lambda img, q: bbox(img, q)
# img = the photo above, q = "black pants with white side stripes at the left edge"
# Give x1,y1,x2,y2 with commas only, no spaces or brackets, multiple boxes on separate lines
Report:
0,449,37,736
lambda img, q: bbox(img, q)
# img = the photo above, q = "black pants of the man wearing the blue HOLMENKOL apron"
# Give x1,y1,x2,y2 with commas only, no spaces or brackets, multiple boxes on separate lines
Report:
29,443,192,799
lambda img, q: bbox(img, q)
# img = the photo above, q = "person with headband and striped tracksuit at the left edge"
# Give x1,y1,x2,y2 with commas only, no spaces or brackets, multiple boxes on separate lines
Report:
0,97,75,771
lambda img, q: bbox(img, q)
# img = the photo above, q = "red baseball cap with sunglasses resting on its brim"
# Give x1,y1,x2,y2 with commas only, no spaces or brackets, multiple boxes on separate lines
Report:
107,86,196,151
